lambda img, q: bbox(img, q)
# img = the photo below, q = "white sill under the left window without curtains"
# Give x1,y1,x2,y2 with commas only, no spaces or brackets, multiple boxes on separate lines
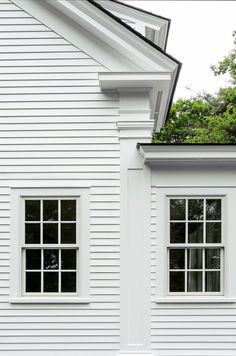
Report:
10,297,90,304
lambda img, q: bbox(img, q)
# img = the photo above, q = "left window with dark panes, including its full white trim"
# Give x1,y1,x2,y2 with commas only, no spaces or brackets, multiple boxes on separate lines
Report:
10,188,89,303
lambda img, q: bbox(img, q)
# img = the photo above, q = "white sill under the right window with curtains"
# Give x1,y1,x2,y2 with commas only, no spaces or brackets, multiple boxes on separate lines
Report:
156,296,236,304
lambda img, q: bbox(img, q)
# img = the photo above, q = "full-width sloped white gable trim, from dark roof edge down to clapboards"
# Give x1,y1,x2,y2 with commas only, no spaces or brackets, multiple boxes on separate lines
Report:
12,0,177,72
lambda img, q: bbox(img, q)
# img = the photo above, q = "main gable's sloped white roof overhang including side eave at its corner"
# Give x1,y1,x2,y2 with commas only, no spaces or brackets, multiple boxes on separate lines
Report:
12,0,181,130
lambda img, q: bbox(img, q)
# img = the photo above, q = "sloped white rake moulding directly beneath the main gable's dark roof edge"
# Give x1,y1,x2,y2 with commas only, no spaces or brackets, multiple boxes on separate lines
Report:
55,0,177,71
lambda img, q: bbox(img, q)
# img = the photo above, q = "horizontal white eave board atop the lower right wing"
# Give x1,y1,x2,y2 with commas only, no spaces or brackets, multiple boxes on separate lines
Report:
138,144,236,166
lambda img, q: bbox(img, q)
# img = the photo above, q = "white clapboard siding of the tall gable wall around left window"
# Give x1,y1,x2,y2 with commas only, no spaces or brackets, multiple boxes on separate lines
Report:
0,0,120,356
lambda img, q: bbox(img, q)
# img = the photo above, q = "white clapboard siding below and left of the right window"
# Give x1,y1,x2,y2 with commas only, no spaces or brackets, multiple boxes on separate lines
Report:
151,187,236,356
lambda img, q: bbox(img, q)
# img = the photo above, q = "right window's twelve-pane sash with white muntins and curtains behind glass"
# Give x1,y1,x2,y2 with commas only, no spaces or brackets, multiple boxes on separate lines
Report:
168,197,224,295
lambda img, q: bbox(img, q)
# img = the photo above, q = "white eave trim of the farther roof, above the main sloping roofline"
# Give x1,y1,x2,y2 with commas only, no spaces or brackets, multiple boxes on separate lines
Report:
96,0,170,49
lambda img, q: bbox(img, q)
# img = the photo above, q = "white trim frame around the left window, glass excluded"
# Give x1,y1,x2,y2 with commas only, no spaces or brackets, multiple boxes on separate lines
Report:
10,188,90,303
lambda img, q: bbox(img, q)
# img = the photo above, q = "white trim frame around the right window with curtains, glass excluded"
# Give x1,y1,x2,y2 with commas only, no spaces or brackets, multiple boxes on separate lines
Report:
156,187,236,303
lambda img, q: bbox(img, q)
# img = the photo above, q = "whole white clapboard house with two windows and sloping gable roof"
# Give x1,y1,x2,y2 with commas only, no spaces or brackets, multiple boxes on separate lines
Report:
0,0,236,356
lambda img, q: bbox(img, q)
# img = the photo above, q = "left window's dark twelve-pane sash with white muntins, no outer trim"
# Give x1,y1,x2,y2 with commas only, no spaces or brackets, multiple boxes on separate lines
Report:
22,197,79,295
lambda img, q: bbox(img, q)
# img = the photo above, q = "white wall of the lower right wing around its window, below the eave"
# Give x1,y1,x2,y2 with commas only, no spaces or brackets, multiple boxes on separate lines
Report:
151,166,236,356
